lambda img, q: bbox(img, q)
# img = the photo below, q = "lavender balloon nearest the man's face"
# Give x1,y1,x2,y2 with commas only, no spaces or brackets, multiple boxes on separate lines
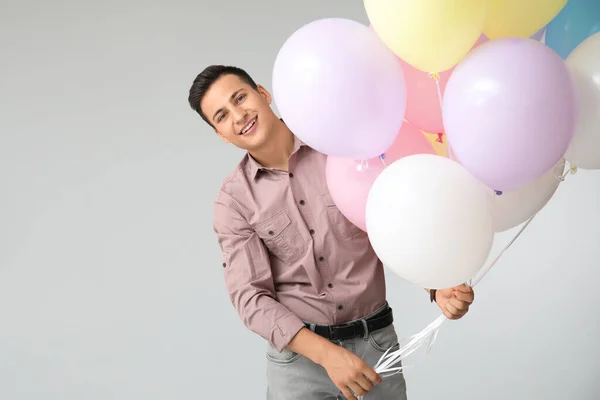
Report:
273,18,406,159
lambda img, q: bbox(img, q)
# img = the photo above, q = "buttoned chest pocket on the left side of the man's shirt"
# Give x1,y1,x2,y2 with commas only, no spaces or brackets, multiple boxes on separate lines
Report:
254,210,306,264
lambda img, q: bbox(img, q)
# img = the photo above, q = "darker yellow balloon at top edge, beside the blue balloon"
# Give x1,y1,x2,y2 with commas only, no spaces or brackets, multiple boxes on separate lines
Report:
483,0,567,39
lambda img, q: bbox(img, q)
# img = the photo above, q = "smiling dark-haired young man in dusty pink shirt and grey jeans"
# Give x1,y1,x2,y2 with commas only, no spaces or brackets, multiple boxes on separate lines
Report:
188,65,473,400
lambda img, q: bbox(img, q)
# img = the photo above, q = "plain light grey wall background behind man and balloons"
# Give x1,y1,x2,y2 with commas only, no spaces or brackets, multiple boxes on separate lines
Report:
0,0,600,400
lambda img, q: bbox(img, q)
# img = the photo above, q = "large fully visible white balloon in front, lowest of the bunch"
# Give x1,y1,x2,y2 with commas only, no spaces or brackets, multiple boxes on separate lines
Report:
366,154,494,289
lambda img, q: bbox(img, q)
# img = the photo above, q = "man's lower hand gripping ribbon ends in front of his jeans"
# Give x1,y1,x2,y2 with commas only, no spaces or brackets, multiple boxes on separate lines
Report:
321,343,381,400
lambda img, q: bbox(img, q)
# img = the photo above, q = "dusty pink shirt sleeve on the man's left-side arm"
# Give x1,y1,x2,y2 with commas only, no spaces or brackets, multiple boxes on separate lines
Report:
213,192,304,351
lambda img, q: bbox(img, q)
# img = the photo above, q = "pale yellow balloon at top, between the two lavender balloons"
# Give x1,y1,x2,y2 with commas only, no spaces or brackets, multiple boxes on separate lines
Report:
364,0,489,72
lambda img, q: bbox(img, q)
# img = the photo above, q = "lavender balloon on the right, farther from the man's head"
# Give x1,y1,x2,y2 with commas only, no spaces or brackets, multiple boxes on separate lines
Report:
443,38,576,190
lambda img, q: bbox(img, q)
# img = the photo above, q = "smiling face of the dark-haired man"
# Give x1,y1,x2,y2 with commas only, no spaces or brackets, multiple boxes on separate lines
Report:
200,75,277,150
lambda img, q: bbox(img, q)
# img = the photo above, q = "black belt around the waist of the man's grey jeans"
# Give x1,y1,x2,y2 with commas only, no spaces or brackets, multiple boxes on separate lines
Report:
306,306,394,340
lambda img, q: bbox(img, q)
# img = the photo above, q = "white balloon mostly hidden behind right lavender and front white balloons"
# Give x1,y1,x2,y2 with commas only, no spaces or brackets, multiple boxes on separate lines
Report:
490,159,565,232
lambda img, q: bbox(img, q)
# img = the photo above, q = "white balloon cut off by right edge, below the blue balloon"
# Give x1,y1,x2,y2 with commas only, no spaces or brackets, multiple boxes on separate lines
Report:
565,32,600,169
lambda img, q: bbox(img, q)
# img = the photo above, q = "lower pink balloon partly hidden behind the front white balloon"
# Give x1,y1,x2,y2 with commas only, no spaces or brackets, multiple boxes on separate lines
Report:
325,123,435,231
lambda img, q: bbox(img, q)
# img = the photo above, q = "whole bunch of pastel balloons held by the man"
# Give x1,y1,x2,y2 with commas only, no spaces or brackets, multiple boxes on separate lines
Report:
273,0,600,288
